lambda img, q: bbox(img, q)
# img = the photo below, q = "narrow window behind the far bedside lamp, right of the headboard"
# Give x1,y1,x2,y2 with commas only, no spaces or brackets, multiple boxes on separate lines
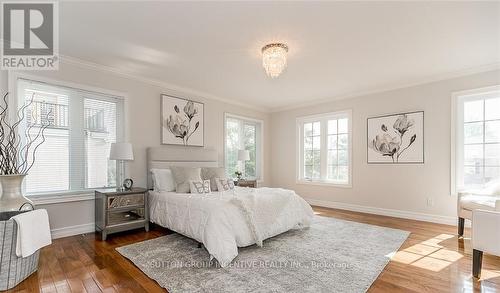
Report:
224,114,263,180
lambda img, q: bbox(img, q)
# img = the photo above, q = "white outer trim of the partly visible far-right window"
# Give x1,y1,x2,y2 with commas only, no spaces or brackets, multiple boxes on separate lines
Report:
450,85,500,196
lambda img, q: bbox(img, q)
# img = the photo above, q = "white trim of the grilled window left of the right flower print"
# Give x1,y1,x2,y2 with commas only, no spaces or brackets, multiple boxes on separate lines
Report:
295,109,353,188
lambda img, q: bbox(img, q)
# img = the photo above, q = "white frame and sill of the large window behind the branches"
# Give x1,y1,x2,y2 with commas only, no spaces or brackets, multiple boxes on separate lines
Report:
8,72,129,200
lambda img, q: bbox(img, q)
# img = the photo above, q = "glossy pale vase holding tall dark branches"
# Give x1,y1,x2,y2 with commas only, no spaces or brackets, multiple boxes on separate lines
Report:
0,174,33,212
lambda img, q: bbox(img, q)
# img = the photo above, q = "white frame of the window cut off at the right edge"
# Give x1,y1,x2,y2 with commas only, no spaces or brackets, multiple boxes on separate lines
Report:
450,85,500,196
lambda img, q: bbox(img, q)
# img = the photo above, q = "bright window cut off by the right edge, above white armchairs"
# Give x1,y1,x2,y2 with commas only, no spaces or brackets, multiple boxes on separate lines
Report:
452,86,500,191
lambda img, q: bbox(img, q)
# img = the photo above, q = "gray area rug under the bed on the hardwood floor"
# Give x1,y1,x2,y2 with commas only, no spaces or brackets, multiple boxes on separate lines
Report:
116,216,409,293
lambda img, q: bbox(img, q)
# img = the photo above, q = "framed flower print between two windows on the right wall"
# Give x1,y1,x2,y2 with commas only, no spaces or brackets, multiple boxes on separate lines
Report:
367,111,424,164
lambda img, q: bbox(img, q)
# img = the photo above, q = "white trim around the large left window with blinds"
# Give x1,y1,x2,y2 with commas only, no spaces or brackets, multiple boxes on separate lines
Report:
7,71,130,198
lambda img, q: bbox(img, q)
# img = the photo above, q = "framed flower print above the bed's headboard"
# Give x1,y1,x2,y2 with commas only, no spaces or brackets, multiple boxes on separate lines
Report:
161,95,205,147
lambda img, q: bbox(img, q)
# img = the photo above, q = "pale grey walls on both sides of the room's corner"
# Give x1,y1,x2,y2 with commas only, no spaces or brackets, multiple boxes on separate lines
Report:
0,63,500,236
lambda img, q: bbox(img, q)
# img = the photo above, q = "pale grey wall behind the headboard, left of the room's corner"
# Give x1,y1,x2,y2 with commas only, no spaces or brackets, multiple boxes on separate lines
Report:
0,62,271,236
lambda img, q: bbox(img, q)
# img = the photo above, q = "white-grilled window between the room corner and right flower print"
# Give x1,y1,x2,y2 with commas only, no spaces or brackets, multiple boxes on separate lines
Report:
297,111,352,186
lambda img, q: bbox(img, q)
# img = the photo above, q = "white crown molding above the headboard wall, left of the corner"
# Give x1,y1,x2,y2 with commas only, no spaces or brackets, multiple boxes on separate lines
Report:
59,54,271,113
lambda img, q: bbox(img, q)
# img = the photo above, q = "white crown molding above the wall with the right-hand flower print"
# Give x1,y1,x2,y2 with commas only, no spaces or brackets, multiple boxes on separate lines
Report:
270,63,500,113
